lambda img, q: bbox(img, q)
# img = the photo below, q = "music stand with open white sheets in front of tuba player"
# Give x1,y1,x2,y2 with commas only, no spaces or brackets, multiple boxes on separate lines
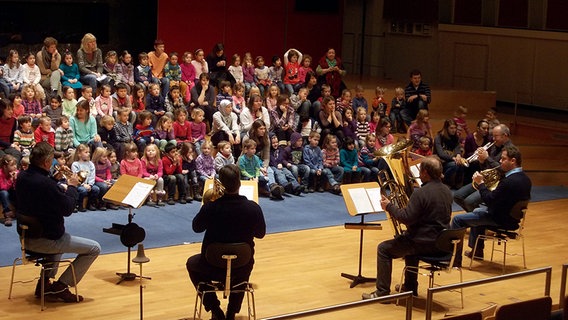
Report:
341,182,383,288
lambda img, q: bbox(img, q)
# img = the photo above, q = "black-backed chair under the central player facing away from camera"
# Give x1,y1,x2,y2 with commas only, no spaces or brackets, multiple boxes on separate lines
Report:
193,243,256,319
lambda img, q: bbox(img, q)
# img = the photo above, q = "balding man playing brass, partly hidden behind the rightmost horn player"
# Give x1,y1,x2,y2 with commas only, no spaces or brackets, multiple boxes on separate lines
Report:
454,124,513,212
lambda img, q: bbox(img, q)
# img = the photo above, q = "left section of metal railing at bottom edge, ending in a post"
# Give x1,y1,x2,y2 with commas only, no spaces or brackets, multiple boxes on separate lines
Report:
262,291,412,320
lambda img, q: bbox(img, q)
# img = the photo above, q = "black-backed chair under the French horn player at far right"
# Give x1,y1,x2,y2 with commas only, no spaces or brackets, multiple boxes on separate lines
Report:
469,200,529,273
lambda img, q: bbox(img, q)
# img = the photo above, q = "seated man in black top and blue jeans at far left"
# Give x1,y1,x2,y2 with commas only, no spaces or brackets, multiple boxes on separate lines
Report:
16,142,101,302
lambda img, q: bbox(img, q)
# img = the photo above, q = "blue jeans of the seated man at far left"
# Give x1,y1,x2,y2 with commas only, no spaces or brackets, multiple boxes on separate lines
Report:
26,233,101,286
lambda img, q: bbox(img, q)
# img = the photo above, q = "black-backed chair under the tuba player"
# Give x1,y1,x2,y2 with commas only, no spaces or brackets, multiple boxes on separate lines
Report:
399,228,466,308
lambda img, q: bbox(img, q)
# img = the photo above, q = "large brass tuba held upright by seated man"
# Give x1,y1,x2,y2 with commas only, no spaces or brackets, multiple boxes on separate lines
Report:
374,138,414,236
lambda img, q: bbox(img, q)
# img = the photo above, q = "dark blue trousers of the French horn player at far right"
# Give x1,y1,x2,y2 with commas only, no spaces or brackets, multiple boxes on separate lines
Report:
450,208,499,250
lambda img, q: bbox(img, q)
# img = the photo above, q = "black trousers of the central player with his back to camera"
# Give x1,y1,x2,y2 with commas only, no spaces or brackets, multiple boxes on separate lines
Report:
185,254,252,314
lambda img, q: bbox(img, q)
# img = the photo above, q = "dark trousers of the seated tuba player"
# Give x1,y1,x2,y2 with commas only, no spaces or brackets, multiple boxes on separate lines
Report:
376,236,438,296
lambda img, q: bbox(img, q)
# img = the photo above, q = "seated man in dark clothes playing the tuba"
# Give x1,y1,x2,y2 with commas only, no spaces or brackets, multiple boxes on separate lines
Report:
363,156,452,299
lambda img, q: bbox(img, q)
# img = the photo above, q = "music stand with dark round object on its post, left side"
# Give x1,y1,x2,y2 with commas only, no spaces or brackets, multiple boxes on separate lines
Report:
103,175,156,284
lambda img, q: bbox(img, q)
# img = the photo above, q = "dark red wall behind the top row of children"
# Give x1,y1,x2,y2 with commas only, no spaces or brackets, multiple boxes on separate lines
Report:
158,0,343,66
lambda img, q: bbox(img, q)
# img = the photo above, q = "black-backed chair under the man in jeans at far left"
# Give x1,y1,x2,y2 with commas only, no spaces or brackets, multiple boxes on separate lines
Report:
8,214,79,311
